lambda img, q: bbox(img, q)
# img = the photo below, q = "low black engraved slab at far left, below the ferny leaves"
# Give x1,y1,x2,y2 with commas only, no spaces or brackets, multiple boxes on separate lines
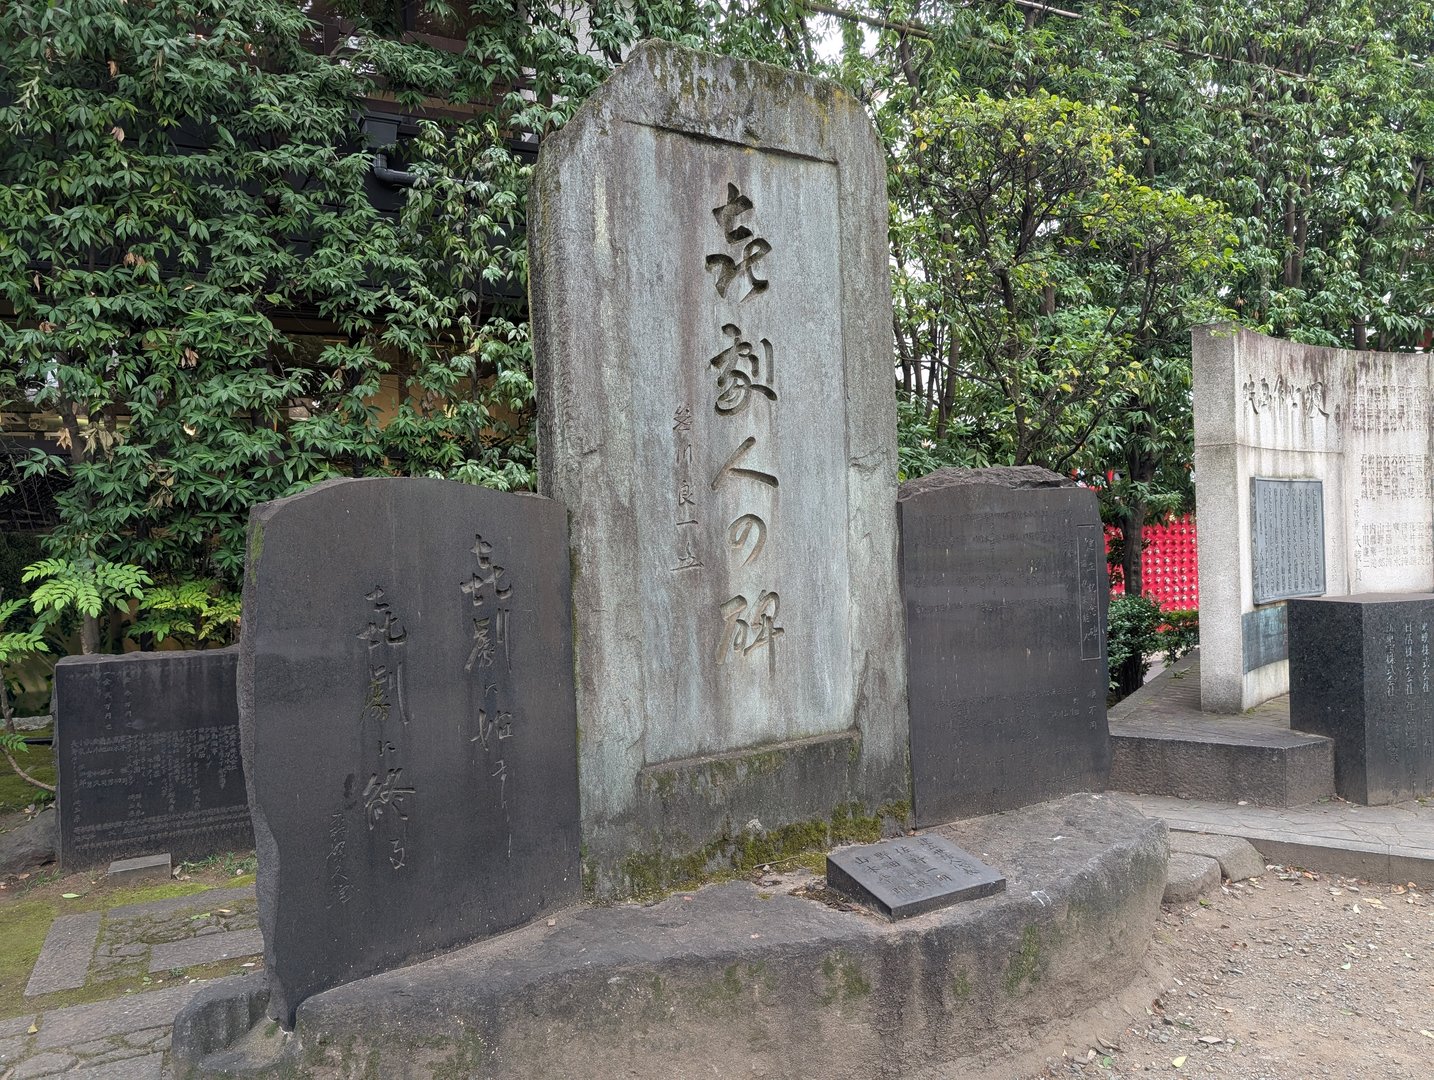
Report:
54,648,254,869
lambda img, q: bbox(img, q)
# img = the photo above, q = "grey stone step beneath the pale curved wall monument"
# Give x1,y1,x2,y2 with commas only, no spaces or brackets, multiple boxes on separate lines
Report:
1110,654,1335,806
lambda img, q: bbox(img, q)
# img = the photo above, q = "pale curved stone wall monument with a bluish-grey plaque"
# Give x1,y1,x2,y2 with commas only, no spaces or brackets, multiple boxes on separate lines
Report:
1193,328,1434,713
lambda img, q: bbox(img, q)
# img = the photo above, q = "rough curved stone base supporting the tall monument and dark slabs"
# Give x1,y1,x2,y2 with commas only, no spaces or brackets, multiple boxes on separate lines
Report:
174,795,1167,1080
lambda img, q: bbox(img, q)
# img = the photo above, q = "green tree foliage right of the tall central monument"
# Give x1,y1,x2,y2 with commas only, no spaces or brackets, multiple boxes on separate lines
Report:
840,0,1434,592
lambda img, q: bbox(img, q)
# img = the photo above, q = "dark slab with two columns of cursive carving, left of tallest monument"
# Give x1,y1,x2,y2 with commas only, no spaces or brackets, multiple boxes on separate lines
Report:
239,479,581,1024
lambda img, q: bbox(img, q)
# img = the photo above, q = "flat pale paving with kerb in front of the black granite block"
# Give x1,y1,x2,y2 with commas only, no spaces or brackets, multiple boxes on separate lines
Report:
1111,795,1434,885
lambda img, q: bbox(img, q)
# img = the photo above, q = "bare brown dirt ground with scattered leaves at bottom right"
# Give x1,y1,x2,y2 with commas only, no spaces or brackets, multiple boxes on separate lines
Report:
1021,869,1434,1080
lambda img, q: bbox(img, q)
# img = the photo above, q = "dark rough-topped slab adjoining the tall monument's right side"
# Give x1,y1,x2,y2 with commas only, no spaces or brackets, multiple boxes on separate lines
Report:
901,468,1110,825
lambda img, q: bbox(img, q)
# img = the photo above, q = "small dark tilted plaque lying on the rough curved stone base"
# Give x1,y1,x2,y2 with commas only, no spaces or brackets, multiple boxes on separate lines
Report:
826,835,1005,919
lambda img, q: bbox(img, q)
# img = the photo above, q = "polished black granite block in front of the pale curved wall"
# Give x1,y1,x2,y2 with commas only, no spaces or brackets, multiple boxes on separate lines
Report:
1289,592,1434,805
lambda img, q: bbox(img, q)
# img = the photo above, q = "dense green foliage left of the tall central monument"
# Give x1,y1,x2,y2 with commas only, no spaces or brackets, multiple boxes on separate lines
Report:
0,0,803,608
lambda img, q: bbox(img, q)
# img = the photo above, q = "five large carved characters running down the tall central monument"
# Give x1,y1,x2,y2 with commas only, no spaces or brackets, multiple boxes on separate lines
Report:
702,184,786,674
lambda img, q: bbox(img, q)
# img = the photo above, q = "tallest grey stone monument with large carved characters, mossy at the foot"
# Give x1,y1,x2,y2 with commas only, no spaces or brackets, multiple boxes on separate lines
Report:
529,43,906,895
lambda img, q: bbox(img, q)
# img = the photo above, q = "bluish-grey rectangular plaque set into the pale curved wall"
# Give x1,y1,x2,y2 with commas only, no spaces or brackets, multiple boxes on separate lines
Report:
1250,478,1325,604
